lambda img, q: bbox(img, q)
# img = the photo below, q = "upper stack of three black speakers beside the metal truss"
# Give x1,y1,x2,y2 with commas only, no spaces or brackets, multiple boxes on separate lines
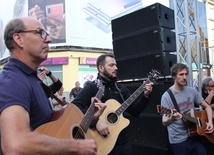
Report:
111,3,177,80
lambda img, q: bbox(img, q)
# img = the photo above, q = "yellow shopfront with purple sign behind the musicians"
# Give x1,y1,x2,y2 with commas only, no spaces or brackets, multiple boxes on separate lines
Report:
41,51,109,92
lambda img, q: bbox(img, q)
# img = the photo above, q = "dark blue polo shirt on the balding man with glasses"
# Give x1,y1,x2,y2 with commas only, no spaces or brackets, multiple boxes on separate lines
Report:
0,58,52,129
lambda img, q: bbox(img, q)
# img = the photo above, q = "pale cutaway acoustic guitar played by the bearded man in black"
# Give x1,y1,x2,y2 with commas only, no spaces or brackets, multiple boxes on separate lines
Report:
90,70,160,155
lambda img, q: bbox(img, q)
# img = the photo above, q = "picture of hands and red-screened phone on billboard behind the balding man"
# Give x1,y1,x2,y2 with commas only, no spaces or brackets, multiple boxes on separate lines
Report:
28,0,66,43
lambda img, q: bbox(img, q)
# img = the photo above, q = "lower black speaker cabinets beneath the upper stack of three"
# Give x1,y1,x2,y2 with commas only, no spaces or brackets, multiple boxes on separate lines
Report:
120,78,174,155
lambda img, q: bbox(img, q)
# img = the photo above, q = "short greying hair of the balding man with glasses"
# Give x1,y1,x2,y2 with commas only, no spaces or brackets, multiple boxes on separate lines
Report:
4,18,25,51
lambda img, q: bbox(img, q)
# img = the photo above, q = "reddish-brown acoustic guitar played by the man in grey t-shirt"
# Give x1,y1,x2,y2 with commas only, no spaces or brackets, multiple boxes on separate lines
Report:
157,105,214,144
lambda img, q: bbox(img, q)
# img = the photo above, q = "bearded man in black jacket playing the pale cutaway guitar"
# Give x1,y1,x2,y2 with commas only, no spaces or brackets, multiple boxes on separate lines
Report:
72,54,153,155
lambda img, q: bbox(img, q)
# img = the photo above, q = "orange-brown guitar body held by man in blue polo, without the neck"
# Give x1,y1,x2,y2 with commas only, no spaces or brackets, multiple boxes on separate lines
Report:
35,104,93,139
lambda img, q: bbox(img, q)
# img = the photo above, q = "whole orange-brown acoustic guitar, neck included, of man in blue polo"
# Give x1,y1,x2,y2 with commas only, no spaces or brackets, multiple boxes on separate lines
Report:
35,81,104,141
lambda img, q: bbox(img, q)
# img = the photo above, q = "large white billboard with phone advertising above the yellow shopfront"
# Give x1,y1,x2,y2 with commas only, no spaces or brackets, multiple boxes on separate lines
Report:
0,0,168,58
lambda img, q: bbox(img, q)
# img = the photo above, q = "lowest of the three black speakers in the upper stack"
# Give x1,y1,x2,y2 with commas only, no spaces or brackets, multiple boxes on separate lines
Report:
117,52,177,80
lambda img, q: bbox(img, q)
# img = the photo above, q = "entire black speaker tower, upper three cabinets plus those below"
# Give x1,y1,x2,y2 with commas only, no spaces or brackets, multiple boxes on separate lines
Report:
112,3,177,155
